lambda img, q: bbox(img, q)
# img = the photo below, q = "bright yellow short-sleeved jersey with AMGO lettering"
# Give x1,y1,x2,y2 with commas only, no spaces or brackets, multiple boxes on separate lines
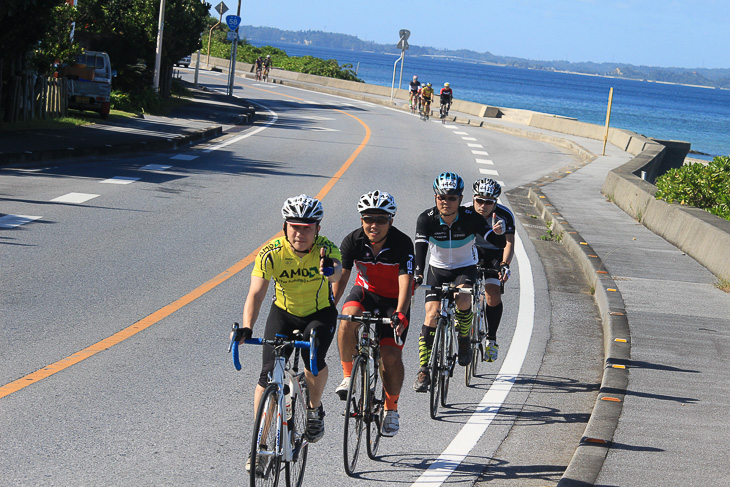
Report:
251,235,342,316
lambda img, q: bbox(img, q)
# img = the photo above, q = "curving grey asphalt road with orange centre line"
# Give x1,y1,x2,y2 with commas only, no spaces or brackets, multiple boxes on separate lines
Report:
0,71,602,487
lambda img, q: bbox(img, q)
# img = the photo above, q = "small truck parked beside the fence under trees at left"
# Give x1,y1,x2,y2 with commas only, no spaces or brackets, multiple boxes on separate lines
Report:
63,51,117,118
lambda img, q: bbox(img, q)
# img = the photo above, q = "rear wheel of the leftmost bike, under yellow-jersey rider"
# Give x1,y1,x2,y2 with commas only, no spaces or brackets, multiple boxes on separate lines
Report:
284,372,309,487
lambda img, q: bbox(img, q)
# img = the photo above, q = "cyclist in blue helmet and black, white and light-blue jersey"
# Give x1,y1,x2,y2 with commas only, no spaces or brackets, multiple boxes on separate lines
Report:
413,172,501,392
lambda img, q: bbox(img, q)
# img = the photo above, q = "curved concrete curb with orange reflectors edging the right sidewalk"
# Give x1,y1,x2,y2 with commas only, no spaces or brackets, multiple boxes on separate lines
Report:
528,187,631,487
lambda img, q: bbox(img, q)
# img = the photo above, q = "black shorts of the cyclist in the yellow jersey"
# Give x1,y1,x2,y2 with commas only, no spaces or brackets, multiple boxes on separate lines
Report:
259,304,337,387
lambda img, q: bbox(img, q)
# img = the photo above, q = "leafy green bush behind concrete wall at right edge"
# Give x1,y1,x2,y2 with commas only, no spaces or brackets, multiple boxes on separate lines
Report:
656,156,730,220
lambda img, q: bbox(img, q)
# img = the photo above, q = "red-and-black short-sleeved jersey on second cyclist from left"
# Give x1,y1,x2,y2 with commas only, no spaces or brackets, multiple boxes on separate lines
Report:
341,227,413,299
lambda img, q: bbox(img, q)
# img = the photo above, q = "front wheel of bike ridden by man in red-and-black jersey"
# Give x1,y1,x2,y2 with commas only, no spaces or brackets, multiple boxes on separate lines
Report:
342,356,367,477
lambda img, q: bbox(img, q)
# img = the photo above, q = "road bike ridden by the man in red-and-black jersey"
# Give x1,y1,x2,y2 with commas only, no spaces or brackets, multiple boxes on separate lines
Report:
337,311,403,477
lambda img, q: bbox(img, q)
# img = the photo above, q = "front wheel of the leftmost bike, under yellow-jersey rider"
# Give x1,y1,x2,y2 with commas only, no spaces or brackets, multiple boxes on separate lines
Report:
249,384,282,487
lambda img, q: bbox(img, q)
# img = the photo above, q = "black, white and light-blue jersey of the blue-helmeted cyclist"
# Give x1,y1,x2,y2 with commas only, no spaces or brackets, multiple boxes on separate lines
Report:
415,206,492,276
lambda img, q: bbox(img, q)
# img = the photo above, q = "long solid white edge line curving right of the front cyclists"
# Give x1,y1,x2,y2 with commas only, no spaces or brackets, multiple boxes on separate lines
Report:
412,234,535,487
